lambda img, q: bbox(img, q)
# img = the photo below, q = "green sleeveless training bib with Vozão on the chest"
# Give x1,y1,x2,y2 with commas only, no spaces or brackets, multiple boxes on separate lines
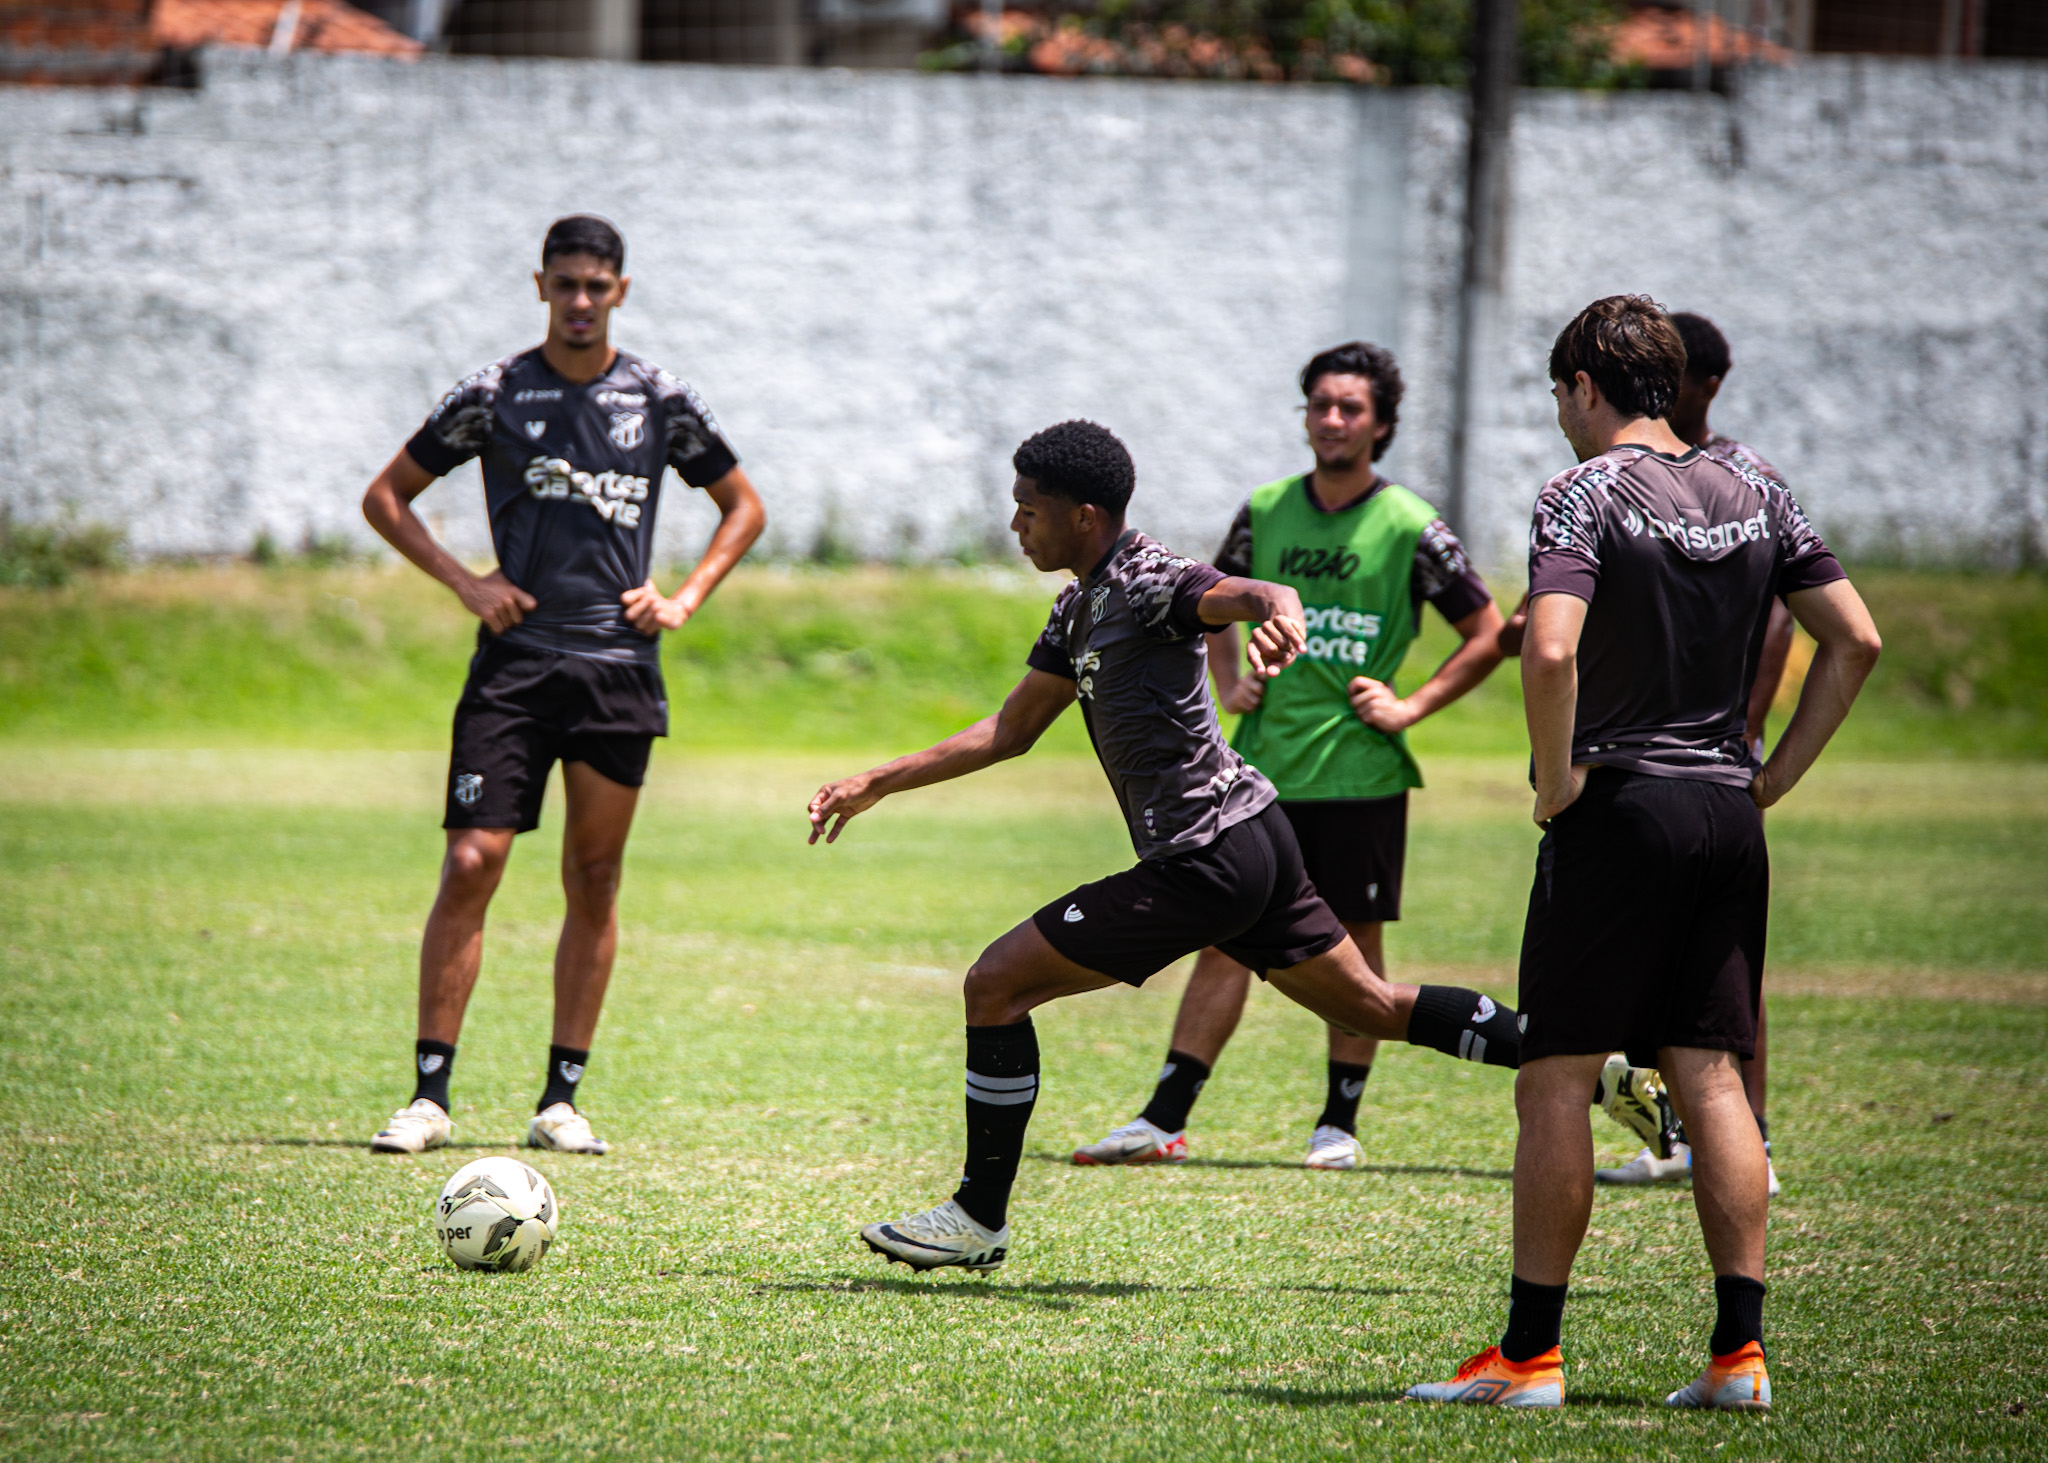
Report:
1231,477,1436,801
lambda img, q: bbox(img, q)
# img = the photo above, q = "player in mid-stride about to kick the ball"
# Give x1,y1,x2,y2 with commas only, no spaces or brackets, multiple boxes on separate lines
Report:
811,422,1518,1270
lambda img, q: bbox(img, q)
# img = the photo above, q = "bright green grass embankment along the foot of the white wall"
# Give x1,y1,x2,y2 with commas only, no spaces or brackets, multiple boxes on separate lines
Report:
0,566,2048,758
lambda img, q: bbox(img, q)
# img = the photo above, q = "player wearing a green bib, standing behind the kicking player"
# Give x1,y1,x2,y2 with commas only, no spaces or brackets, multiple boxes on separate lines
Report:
1073,342,1501,1168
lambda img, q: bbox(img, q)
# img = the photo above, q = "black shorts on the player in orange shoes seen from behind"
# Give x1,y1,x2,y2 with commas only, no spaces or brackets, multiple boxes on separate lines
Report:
1520,766,1772,1068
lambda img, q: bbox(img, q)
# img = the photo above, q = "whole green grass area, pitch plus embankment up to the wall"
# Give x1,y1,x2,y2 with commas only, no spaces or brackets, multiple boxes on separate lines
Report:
0,568,2048,1463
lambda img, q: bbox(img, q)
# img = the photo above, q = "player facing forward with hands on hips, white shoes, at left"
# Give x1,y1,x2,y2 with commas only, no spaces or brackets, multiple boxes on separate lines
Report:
362,215,762,1154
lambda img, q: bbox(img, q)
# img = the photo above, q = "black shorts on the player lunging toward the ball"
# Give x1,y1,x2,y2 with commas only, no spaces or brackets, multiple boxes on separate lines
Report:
1032,803,1343,986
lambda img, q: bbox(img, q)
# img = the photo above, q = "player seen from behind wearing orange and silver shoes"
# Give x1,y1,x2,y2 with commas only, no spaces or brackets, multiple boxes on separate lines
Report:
1409,295,1880,1410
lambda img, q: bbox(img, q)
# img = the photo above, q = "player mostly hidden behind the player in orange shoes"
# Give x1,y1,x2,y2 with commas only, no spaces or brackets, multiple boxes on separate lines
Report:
1593,311,1792,1199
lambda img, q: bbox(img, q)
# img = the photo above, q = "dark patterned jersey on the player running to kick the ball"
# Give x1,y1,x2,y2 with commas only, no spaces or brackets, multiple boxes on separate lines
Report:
1030,529,1274,859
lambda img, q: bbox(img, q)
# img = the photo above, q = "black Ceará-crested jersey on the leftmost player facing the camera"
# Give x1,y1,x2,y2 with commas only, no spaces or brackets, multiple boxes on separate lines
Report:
406,346,739,664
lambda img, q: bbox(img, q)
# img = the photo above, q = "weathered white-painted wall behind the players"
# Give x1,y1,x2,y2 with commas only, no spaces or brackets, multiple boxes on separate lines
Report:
0,53,2048,563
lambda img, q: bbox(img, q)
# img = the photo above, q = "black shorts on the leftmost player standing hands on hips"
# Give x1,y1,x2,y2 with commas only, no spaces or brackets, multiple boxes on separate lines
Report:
440,641,668,834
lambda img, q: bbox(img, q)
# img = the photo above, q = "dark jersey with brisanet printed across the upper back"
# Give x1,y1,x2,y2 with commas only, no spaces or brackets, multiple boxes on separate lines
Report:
1530,445,1843,787
